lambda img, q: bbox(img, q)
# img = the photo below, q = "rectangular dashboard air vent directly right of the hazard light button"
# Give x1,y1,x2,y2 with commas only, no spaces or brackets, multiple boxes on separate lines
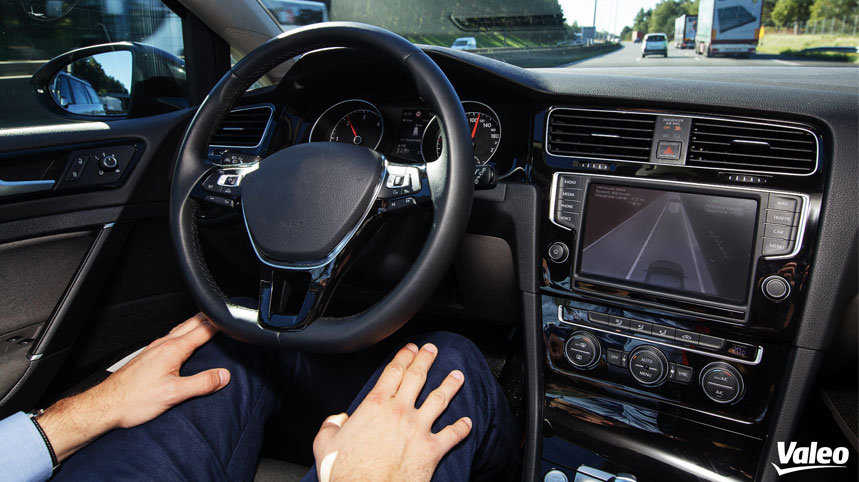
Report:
686,119,817,174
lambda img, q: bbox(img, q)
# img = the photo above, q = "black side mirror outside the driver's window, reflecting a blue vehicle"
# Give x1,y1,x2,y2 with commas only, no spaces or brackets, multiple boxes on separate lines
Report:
30,42,188,119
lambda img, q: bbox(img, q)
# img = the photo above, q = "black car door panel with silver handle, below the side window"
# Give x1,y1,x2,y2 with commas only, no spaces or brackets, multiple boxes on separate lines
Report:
0,109,194,417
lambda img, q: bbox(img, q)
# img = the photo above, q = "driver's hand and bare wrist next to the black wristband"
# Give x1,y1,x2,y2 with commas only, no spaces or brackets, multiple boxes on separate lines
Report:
38,313,230,460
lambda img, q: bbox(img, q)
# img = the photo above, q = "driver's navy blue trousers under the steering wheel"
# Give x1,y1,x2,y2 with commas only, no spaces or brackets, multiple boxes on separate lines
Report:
58,332,520,482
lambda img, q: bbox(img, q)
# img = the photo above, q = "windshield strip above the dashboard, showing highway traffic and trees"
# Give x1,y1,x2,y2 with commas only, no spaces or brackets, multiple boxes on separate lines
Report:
259,0,859,67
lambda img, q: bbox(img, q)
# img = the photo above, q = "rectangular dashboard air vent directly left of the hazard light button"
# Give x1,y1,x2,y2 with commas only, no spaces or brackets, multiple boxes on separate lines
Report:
546,109,656,162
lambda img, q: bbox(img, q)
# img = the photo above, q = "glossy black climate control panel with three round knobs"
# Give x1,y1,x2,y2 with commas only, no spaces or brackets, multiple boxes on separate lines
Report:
544,298,779,423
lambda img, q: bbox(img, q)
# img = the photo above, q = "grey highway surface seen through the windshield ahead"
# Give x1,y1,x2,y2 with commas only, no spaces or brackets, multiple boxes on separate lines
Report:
561,42,856,68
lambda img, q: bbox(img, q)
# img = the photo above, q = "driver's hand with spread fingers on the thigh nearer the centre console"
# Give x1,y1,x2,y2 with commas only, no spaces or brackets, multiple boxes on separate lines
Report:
313,343,471,482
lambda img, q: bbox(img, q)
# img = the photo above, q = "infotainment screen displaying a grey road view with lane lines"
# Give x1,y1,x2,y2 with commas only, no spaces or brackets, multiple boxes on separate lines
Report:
578,183,758,304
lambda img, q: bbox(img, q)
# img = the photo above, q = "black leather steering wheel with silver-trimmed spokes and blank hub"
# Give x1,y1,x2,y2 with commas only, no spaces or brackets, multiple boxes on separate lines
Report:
170,22,473,353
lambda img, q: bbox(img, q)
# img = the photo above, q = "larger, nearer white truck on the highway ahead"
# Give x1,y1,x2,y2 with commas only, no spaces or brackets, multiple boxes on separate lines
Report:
695,0,764,58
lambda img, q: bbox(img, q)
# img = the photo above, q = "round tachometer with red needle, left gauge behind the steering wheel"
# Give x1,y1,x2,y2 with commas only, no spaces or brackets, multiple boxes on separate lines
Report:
310,99,385,149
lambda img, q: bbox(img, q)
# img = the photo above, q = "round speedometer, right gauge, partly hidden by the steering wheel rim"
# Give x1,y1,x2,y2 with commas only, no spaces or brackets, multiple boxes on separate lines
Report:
421,101,501,164
